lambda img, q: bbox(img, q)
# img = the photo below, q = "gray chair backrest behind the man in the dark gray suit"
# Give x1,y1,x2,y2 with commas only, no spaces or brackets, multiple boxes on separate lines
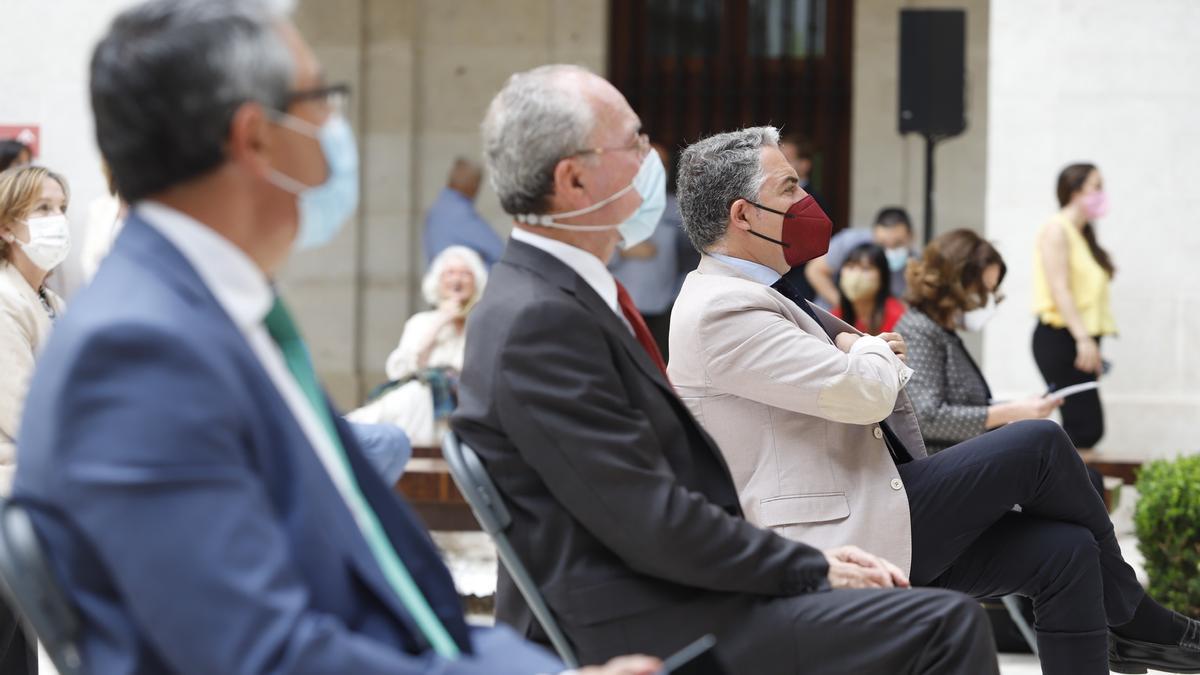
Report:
442,432,580,668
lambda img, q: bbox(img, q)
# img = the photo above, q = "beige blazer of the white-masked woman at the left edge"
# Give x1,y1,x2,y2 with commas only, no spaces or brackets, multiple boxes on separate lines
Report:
0,261,64,496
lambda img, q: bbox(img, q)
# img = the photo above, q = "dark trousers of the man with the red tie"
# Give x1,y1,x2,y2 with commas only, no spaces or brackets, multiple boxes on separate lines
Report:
569,581,1000,675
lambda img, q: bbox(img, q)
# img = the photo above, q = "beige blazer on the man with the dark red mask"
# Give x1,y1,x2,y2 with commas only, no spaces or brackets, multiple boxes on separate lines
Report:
667,256,925,572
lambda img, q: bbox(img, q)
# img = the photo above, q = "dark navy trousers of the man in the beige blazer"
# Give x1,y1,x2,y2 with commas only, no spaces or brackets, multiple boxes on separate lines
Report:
899,420,1145,675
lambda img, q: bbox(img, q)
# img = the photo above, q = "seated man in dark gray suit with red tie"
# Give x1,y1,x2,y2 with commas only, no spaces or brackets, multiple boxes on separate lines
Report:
451,66,997,674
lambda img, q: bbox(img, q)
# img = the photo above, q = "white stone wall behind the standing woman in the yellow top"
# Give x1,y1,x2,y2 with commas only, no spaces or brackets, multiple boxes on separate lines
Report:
984,0,1200,459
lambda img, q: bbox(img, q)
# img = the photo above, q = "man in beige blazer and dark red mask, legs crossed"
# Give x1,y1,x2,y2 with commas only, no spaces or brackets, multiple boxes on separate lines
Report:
667,127,1200,674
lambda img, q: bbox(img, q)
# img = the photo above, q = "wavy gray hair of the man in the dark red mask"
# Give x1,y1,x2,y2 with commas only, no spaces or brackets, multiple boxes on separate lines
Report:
676,126,779,252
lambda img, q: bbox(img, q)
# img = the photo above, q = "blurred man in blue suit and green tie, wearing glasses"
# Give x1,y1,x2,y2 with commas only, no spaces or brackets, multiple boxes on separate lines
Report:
14,0,658,675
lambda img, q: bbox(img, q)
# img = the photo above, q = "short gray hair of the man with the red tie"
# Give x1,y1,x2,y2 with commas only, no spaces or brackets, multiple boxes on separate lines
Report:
482,65,595,215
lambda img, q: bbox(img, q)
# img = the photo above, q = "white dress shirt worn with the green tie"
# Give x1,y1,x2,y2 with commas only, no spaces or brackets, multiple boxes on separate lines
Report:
136,202,367,530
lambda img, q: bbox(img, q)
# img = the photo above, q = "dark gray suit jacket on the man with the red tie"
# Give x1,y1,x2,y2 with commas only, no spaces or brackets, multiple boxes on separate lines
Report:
451,240,828,673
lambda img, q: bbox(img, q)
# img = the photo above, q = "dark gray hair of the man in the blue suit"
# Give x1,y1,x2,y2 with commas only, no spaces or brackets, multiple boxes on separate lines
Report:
91,0,294,202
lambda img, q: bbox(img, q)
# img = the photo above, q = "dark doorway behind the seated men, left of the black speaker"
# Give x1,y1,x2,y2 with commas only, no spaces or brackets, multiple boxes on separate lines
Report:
608,0,854,227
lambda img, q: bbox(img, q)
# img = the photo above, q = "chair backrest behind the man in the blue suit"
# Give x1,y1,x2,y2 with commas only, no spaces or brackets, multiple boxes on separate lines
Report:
0,500,85,675
